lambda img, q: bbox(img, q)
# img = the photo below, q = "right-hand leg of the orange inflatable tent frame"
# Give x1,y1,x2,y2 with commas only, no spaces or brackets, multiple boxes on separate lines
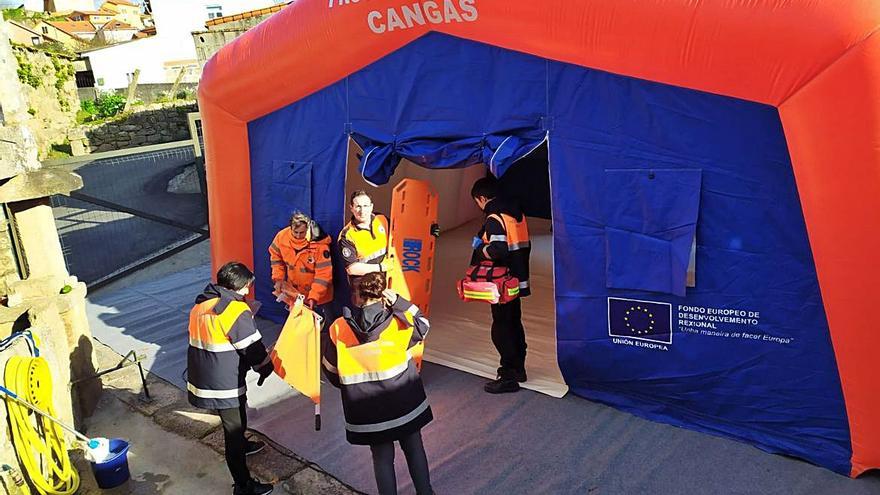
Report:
779,33,880,476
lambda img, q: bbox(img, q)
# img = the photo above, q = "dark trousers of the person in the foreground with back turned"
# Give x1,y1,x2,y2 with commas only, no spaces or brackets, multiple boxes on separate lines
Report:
370,431,434,495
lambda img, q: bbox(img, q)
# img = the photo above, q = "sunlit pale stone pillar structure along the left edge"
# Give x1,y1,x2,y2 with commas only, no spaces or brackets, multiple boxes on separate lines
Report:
0,21,101,480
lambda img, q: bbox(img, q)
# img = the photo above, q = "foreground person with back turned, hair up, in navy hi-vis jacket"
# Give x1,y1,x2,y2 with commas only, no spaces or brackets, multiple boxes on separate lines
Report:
322,273,433,495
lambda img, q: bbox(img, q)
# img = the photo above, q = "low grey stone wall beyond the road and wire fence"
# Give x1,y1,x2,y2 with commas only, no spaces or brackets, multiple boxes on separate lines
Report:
80,102,198,153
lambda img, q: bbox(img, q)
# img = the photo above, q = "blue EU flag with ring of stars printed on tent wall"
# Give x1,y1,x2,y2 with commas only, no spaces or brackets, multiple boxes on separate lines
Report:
608,297,672,344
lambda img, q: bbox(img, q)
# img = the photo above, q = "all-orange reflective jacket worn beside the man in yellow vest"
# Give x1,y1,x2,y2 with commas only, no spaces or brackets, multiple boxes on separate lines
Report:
269,227,333,304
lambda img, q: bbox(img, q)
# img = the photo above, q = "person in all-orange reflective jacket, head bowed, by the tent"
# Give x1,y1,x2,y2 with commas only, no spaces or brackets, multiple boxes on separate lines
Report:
269,212,333,315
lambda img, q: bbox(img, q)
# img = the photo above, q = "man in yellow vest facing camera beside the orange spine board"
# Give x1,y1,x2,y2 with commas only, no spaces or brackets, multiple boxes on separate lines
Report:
338,191,390,305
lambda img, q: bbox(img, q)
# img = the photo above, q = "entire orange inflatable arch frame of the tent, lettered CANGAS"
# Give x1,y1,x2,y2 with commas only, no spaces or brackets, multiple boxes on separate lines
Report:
199,0,880,476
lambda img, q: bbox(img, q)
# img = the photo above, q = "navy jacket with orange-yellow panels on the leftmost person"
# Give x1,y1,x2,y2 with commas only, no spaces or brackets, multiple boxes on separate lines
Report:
186,285,268,409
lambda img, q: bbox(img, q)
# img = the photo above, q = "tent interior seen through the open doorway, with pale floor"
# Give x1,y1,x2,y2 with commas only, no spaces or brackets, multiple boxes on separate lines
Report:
345,139,568,397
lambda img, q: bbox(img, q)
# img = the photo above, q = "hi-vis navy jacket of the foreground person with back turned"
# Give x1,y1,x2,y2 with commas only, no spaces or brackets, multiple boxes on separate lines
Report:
322,297,433,445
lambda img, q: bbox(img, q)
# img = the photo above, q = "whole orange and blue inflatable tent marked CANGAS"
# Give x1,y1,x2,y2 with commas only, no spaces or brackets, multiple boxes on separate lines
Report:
199,0,880,476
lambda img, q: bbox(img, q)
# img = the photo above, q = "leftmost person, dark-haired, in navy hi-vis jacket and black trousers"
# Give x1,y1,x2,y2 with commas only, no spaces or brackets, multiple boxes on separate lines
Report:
186,262,272,495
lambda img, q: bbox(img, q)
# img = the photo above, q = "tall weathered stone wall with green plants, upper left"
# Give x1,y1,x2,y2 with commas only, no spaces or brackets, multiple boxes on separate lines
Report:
12,46,79,158
